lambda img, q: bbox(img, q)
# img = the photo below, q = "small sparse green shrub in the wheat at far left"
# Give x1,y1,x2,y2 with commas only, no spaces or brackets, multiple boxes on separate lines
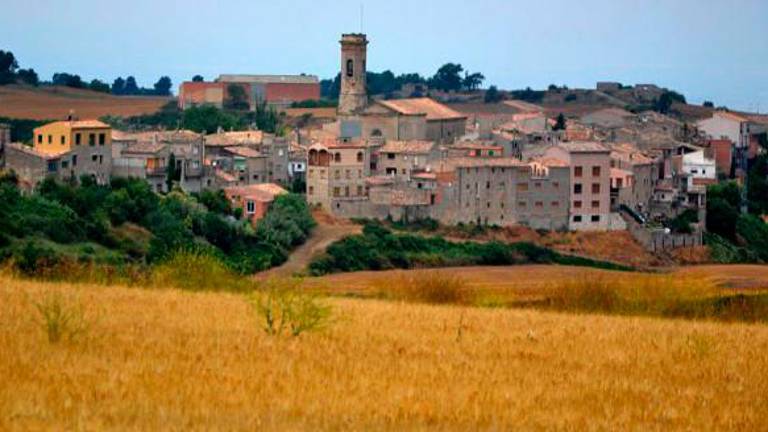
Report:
34,292,89,344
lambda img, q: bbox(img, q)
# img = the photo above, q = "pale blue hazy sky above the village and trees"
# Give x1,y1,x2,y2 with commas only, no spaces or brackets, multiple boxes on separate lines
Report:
0,0,768,112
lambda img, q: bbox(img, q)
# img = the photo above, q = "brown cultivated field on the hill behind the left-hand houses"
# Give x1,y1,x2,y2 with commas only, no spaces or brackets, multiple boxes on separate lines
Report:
0,85,171,120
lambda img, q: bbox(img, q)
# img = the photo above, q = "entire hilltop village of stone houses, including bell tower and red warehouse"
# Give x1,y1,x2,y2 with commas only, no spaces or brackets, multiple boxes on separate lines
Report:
0,34,768,251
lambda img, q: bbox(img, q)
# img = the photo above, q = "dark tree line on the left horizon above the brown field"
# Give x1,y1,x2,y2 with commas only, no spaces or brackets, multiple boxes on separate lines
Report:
0,50,173,96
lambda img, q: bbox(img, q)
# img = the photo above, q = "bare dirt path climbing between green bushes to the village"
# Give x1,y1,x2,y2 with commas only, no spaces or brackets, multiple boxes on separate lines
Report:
254,213,363,279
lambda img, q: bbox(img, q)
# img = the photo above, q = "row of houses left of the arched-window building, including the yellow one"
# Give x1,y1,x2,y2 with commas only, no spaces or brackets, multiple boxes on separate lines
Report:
0,120,296,224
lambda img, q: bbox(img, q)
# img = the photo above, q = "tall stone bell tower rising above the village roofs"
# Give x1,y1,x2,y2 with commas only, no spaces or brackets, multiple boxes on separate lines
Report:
339,33,368,115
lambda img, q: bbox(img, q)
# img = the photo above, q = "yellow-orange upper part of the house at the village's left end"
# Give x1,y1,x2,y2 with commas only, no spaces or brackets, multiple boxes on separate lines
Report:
33,120,112,155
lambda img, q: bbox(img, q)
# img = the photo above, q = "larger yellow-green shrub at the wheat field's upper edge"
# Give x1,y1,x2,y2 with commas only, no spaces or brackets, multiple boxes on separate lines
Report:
249,279,332,337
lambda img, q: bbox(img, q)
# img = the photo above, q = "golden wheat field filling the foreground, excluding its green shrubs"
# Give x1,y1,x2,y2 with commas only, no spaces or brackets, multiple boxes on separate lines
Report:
0,268,768,431
